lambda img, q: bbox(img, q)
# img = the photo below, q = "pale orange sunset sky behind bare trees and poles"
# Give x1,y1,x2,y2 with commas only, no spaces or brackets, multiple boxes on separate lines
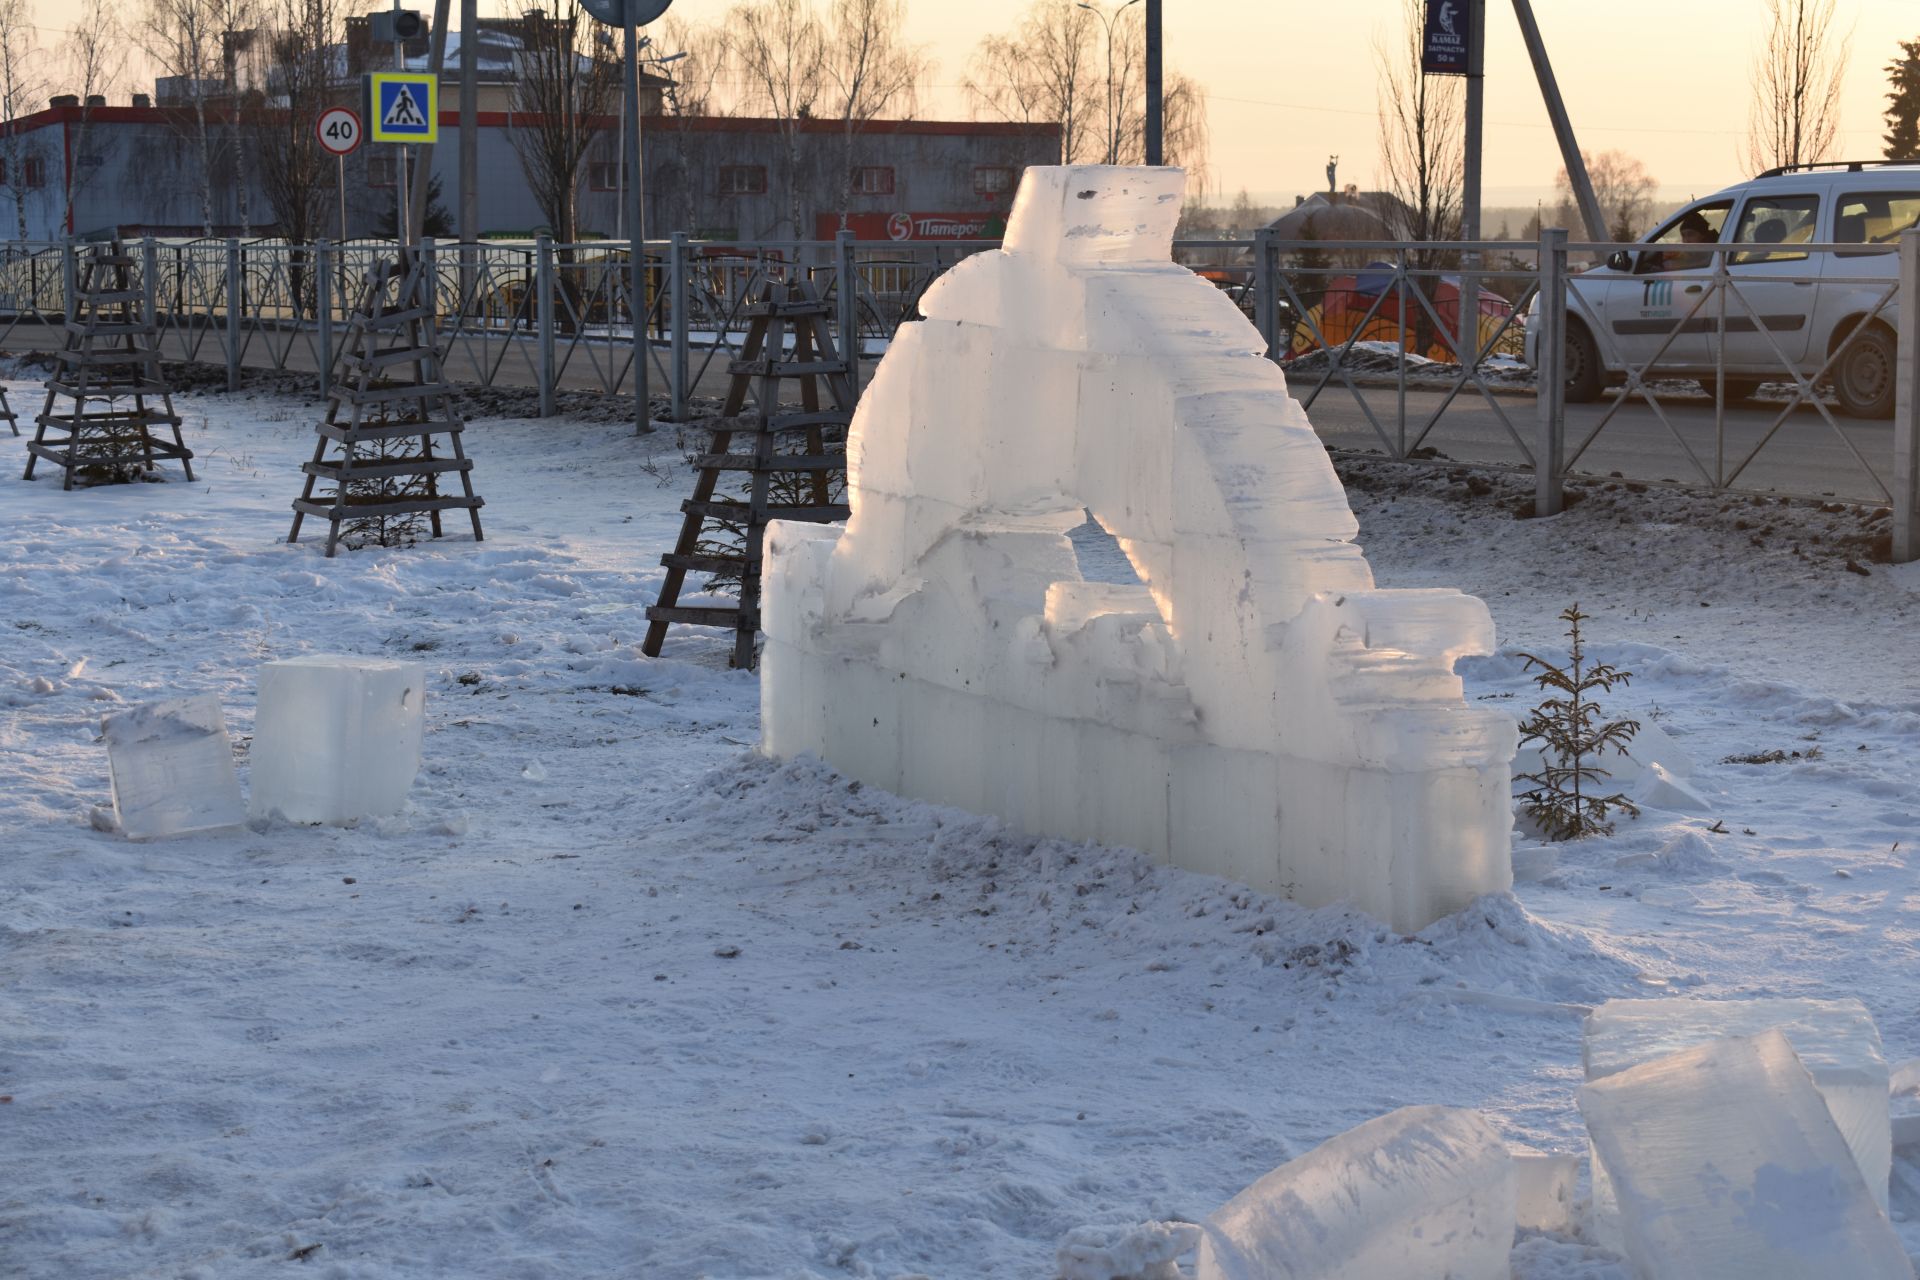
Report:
36,0,1920,205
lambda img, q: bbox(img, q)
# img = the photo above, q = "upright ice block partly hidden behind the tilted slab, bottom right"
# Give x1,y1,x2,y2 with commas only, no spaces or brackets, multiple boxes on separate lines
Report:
1580,998,1893,1245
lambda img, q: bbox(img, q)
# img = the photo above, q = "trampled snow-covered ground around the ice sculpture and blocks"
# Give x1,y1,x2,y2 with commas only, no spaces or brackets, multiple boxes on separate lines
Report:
0,384,1920,1280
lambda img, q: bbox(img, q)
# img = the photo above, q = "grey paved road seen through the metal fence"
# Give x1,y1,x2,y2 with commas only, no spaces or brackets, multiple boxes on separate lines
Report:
0,324,1893,503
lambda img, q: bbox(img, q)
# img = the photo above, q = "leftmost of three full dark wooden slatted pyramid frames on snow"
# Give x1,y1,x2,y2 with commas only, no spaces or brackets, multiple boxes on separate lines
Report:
23,240,194,489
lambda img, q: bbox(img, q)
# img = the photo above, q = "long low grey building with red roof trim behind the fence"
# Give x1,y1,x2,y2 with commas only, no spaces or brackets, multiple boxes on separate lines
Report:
0,91,1060,242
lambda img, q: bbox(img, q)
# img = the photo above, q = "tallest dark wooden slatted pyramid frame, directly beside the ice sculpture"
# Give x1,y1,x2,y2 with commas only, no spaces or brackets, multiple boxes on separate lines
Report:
641,280,854,668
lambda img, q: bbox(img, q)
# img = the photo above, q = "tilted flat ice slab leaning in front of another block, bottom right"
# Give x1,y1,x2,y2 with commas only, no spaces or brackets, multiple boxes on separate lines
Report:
1580,1029,1914,1280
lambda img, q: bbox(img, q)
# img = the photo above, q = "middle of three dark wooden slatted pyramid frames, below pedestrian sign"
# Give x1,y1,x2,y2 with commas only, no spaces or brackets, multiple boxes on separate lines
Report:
286,246,486,558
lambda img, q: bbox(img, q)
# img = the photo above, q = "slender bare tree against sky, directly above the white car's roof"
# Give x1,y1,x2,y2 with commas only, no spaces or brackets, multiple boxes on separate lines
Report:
1747,0,1851,173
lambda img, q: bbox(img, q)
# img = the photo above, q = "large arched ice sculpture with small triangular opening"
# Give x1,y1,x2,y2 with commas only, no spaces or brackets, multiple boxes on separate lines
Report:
760,165,1515,931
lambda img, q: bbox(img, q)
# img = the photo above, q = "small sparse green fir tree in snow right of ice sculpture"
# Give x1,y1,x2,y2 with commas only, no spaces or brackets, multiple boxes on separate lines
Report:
1513,603,1640,841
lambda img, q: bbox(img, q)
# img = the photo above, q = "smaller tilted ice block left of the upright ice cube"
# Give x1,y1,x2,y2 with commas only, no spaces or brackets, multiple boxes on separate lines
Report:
100,693,246,841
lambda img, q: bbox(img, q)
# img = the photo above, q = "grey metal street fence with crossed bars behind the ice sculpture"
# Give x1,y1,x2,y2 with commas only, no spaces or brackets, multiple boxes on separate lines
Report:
0,230,1920,558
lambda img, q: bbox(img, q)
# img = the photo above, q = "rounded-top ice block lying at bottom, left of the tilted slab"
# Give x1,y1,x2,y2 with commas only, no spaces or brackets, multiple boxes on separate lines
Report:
1194,1107,1513,1280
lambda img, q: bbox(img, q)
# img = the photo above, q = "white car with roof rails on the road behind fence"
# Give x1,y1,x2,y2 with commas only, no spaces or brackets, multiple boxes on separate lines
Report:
1526,161,1920,418
